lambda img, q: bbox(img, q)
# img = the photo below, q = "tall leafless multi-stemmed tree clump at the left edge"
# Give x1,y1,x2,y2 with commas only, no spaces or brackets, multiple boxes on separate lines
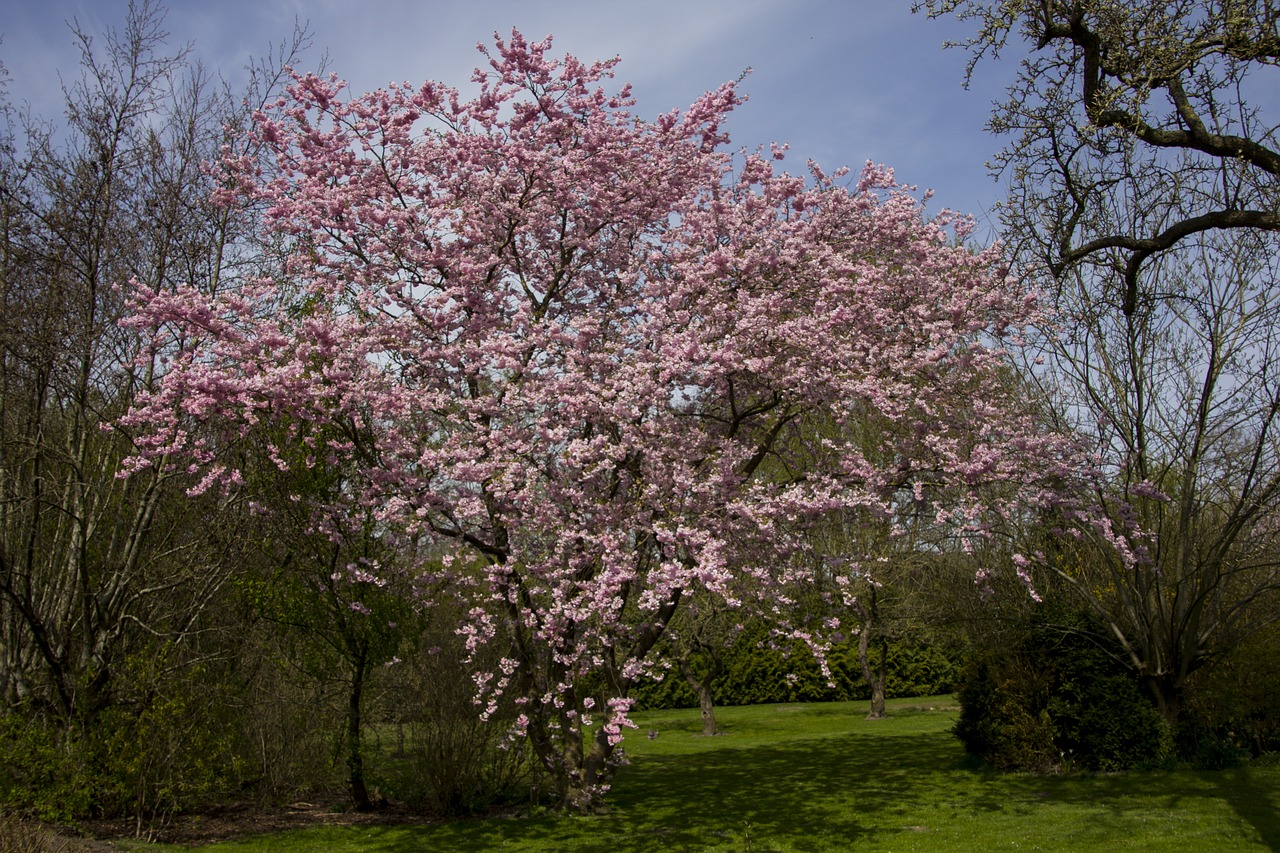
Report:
0,0,305,720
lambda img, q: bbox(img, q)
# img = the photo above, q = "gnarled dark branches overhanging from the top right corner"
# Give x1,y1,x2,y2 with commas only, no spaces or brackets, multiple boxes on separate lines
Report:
914,0,1280,314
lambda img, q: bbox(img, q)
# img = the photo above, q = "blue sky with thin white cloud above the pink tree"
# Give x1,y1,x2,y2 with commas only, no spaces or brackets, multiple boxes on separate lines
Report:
0,0,1016,235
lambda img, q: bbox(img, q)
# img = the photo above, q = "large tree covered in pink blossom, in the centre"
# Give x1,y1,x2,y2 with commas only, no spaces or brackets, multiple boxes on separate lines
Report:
123,33,1066,808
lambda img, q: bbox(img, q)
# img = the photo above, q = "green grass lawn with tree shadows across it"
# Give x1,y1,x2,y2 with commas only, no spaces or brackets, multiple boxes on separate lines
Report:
137,697,1280,853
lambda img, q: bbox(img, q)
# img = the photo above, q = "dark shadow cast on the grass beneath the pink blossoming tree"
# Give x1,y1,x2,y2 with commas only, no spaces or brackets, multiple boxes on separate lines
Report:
345,734,962,853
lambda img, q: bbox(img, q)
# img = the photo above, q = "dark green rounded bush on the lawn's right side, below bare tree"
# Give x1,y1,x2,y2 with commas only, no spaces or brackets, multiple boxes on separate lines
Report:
955,611,1171,771
